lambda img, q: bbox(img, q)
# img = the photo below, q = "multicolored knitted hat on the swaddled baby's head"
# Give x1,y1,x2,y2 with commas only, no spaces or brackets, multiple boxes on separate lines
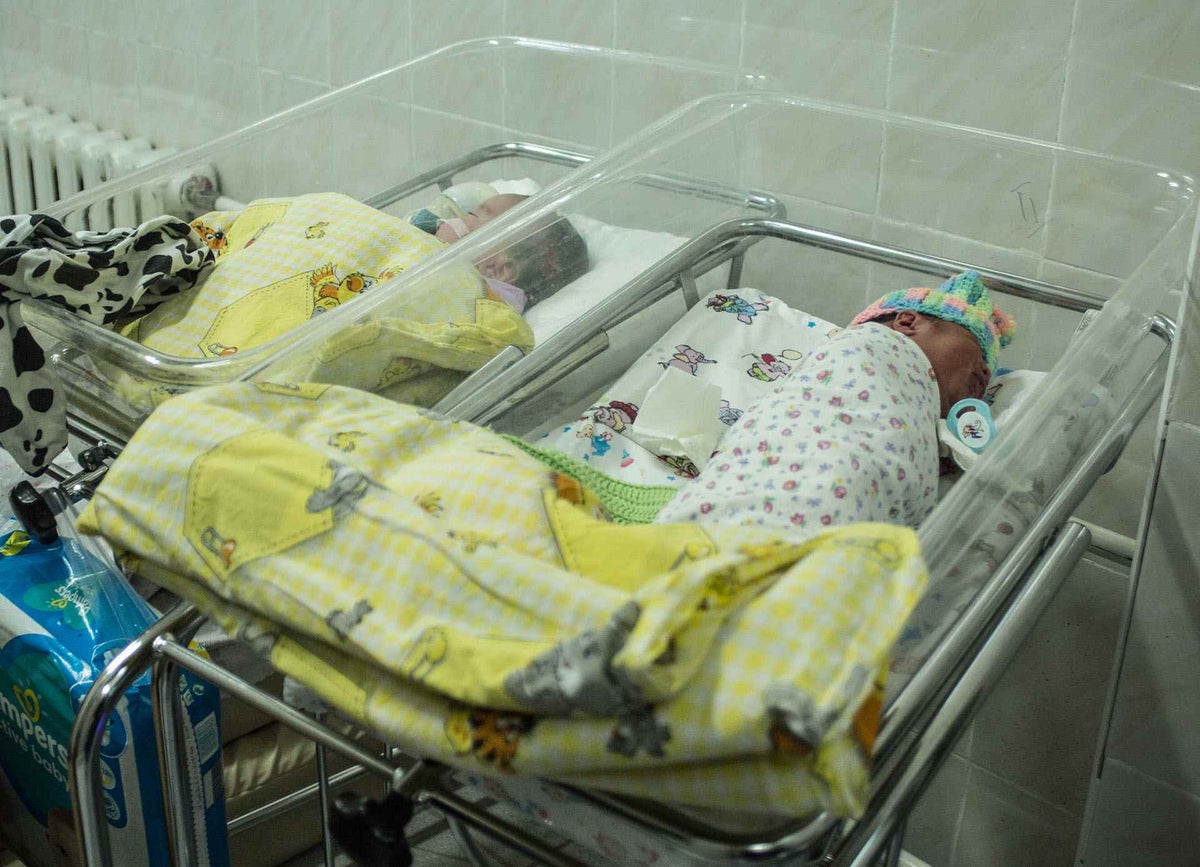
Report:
850,271,1016,370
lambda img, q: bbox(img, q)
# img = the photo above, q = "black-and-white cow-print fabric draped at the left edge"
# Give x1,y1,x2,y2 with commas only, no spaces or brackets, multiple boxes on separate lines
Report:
0,214,215,476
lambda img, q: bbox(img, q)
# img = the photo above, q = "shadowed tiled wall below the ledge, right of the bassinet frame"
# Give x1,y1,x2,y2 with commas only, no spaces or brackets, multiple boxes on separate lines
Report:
906,556,1129,867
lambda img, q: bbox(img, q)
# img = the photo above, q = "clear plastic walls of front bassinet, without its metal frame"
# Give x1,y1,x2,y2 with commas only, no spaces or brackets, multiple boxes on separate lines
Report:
417,94,1196,710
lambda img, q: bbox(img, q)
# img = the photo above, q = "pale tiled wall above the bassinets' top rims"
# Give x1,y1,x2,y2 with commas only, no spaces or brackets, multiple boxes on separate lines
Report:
7,0,1200,172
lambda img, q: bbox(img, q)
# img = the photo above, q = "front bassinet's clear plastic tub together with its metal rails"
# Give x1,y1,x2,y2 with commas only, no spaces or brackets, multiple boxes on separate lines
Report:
417,94,1196,865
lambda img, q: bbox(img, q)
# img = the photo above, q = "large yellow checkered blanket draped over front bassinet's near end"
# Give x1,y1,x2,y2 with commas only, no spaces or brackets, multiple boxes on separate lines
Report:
82,383,925,814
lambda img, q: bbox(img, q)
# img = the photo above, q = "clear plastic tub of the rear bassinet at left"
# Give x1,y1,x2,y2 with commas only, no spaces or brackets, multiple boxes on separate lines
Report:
24,37,775,441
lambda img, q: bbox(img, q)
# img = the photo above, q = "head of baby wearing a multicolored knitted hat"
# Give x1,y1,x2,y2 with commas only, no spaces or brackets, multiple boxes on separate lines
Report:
851,271,1015,417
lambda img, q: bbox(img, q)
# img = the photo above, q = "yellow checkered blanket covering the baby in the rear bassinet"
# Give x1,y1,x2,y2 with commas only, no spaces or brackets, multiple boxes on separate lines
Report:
110,193,533,406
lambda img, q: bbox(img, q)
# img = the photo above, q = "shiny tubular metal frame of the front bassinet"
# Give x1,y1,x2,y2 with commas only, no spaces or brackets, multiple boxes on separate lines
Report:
60,212,1175,867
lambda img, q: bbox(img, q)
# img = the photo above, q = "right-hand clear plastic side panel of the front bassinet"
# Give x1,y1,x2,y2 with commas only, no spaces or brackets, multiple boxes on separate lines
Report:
888,212,1193,695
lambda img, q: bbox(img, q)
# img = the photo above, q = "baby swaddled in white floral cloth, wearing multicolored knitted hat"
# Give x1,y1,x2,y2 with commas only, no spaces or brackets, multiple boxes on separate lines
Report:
655,271,1014,530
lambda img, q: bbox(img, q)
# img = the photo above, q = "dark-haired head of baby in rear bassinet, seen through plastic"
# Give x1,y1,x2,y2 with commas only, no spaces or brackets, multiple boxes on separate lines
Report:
475,213,589,306
